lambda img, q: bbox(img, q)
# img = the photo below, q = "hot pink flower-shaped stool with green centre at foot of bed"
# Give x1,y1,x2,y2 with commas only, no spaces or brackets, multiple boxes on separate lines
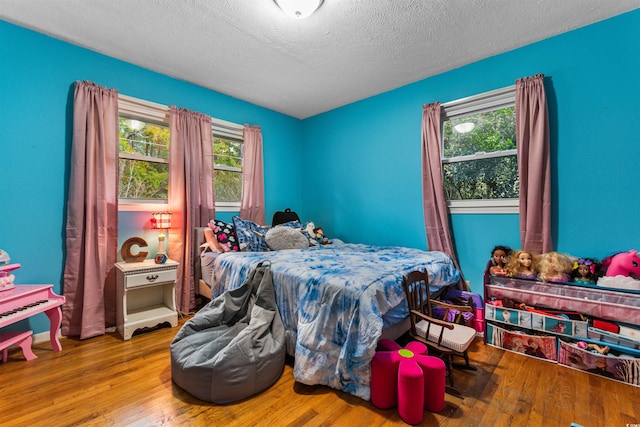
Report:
371,339,446,424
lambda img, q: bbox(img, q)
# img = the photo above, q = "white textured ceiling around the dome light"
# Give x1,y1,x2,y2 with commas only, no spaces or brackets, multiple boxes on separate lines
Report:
0,0,640,118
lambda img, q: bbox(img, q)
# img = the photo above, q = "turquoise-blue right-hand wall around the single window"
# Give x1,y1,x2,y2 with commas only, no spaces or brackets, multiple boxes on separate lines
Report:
303,10,640,292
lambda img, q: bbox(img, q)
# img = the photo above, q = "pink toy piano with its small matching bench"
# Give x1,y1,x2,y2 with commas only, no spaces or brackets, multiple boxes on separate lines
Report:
0,264,65,362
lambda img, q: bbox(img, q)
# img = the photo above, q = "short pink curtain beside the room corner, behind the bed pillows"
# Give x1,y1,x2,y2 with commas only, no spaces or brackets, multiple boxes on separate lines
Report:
240,125,265,225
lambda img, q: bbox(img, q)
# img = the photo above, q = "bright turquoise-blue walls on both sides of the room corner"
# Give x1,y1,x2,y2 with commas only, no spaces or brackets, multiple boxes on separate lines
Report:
0,10,640,332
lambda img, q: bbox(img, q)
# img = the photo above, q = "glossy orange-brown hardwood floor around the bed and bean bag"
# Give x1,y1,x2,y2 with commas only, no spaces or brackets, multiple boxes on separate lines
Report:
0,320,640,427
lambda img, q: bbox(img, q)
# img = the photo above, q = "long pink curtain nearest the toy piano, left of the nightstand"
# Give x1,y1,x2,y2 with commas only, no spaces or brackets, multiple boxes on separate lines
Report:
62,82,118,339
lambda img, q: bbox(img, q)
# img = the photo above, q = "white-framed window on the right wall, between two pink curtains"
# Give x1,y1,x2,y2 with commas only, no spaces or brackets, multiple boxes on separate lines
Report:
441,86,520,213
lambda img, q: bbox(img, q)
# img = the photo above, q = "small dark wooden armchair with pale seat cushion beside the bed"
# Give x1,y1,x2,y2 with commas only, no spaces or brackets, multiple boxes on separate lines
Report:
403,270,476,394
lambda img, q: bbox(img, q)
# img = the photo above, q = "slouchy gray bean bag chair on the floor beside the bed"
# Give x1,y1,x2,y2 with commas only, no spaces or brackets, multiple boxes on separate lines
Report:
171,264,285,403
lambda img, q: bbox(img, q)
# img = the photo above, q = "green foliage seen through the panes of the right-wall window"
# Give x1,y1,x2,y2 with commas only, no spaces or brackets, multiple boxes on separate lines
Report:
442,107,519,200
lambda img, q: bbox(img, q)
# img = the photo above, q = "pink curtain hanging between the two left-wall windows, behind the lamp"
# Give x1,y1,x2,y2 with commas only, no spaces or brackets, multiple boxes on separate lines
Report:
168,106,215,313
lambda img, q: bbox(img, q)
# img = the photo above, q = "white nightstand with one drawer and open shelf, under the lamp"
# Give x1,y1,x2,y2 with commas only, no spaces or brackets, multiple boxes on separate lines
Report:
116,259,178,340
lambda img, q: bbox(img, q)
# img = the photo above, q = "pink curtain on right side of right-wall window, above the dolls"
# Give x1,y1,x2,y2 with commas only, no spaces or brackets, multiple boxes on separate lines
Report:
516,74,553,253
